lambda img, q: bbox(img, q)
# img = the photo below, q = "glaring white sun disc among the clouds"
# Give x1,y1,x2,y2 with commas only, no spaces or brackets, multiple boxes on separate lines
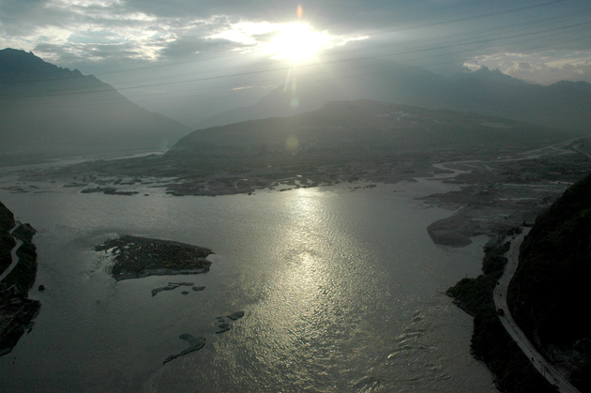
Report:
268,23,331,64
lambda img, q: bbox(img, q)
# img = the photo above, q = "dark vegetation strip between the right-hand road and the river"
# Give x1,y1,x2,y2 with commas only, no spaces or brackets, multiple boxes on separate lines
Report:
447,236,556,393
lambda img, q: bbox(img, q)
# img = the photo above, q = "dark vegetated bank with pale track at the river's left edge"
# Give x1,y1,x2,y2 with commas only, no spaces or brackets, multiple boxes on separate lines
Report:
0,202,41,356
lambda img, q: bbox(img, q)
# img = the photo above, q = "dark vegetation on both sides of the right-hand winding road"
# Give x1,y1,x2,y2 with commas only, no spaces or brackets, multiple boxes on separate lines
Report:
448,175,591,392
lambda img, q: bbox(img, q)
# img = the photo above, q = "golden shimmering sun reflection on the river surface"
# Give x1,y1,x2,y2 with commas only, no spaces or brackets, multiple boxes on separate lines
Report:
229,189,382,390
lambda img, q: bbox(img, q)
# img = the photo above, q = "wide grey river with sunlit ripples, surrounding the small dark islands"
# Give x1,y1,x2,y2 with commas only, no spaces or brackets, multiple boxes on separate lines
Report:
0,166,496,393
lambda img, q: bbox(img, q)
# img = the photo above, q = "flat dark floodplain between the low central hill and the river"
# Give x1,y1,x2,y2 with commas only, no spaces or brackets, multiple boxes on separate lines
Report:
5,136,591,247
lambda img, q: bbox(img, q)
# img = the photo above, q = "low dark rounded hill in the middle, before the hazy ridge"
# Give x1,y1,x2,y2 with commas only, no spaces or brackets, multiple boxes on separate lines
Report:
167,100,565,160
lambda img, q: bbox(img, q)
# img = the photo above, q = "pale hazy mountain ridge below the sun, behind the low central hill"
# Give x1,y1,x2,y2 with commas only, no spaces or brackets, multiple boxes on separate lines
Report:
199,63,591,130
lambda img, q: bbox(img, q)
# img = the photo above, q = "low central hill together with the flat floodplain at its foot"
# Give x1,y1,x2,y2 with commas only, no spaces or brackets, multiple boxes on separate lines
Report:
11,101,591,247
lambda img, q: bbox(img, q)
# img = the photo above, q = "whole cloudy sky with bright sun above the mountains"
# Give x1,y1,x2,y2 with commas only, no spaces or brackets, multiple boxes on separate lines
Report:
0,0,591,123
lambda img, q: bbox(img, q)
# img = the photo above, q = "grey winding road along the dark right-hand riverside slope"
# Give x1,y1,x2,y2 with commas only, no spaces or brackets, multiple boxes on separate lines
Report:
494,228,580,393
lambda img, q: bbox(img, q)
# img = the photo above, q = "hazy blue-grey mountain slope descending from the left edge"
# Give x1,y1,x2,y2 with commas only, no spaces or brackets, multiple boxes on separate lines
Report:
0,49,189,162
